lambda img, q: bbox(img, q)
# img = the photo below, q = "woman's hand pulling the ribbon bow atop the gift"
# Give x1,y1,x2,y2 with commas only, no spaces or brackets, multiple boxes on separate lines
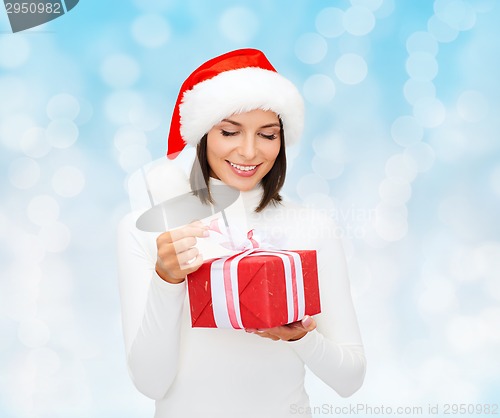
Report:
156,221,208,284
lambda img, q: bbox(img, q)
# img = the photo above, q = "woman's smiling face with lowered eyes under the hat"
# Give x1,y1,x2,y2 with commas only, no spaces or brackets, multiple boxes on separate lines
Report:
207,109,281,191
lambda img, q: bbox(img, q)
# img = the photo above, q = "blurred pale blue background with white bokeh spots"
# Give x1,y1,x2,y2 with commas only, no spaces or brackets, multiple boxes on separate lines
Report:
0,0,500,418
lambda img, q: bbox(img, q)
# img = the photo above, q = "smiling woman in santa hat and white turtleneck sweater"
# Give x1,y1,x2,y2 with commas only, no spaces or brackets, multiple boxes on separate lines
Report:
119,49,365,418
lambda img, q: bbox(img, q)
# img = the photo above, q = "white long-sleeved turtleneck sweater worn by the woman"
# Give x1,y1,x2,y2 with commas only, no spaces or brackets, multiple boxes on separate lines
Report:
118,180,365,418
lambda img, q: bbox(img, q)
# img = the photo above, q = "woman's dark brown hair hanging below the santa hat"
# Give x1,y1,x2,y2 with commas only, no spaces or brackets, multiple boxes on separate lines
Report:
189,118,286,212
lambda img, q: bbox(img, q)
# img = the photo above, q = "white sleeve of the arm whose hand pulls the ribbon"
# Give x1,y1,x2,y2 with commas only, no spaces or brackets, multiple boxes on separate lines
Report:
118,214,186,400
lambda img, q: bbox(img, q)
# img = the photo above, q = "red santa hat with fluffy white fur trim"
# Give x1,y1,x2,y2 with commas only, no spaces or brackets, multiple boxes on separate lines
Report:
167,49,304,159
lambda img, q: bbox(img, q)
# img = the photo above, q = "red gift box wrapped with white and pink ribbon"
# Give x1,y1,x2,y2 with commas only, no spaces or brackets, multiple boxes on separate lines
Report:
187,249,321,329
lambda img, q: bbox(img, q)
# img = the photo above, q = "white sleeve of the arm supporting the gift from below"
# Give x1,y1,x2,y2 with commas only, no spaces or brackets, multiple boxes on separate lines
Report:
280,211,366,397
